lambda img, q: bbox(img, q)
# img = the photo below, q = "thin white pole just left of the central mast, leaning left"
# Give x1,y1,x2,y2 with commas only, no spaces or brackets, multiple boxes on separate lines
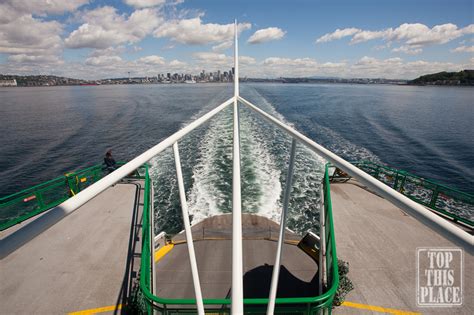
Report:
173,142,204,315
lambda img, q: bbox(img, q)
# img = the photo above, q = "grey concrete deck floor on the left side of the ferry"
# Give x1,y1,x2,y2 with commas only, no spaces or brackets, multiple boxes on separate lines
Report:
0,184,143,314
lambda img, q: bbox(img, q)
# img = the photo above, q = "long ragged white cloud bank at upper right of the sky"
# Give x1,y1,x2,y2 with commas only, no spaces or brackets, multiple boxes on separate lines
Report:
316,23,474,49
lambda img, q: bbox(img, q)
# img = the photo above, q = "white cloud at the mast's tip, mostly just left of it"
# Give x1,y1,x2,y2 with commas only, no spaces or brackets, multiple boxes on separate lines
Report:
153,17,251,45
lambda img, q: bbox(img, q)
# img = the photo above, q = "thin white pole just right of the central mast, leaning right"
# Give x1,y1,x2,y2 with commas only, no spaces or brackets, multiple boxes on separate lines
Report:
267,139,296,315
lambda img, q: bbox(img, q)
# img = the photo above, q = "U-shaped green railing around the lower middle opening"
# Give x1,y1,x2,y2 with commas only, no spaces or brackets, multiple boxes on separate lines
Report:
140,165,339,314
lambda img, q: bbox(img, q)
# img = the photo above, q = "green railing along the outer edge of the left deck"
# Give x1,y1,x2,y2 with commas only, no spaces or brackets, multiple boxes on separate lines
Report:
0,162,141,231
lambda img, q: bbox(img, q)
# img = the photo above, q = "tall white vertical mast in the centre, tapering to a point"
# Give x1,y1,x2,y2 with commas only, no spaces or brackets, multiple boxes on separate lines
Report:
231,20,244,315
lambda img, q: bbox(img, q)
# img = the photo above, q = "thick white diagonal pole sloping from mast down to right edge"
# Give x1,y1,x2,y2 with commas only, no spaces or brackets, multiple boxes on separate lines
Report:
239,96,474,254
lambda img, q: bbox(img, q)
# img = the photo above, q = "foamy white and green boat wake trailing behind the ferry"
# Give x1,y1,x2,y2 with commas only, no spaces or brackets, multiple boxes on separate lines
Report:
151,86,370,233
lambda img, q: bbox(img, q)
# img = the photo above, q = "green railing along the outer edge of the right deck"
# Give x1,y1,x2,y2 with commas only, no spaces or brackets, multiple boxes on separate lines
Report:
354,161,474,229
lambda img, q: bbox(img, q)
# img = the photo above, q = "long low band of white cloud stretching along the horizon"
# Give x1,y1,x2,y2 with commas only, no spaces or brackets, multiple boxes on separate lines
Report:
0,51,474,79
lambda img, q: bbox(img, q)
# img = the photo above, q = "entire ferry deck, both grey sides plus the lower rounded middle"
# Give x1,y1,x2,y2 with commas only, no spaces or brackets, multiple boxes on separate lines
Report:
0,181,474,314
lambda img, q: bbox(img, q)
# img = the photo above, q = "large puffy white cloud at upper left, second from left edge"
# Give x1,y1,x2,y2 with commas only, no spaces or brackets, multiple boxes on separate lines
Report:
65,6,162,49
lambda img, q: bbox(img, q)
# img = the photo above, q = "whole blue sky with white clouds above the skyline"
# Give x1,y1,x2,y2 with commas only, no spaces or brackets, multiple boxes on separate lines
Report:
0,0,474,79
